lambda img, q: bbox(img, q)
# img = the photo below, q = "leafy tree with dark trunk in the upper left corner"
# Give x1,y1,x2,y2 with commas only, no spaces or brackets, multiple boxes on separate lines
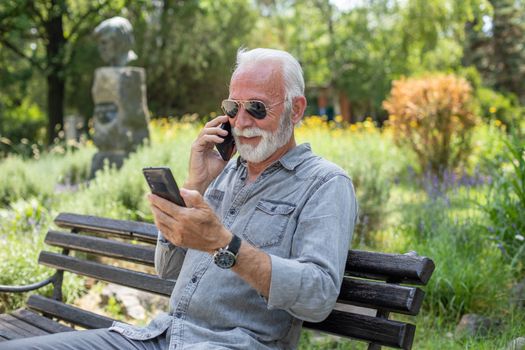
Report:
0,0,124,143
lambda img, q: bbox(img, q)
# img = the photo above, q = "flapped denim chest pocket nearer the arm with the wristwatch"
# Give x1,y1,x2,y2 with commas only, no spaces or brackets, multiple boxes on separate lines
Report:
242,199,295,248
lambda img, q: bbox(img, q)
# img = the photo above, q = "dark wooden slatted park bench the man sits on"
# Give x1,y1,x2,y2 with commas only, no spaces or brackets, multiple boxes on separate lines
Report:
0,213,434,349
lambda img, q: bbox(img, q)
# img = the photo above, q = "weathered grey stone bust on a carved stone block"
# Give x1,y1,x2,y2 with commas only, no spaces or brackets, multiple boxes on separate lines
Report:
90,17,149,178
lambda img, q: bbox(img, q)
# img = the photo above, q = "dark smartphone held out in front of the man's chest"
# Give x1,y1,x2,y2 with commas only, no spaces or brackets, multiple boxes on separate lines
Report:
142,167,186,207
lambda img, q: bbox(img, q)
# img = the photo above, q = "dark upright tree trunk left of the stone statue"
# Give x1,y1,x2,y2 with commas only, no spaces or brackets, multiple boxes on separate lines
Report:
45,0,66,144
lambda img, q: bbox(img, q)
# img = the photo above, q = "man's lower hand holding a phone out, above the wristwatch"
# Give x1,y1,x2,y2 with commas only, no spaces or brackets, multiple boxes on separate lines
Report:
148,188,232,253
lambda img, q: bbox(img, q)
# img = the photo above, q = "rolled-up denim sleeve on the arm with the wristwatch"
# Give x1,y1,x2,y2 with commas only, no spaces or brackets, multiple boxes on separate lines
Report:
268,175,358,322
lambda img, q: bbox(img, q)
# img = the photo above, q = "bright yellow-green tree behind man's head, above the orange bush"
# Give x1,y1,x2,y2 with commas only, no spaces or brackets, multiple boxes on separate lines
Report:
252,0,487,121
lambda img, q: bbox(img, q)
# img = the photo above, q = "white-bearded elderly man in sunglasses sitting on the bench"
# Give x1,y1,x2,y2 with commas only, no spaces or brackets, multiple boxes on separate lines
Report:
0,49,357,350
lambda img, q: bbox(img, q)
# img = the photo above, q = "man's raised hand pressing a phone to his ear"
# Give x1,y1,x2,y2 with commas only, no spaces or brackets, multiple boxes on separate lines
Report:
184,115,232,194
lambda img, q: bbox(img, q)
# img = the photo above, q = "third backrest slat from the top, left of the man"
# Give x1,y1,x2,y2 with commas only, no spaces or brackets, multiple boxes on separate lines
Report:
38,251,175,296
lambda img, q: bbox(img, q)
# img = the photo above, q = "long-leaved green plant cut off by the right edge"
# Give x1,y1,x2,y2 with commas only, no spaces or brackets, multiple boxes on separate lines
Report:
484,139,525,273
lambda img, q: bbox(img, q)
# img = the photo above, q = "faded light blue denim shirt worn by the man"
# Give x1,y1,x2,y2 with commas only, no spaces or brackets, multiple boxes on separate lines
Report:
111,144,357,350
